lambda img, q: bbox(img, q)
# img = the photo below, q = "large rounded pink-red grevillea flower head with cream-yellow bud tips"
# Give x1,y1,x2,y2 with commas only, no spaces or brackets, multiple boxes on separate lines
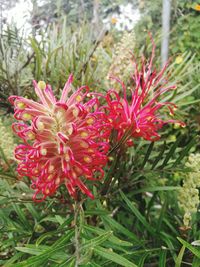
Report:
9,76,109,201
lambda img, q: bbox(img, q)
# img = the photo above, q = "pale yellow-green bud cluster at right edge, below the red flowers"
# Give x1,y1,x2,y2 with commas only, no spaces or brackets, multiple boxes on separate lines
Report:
179,153,200,226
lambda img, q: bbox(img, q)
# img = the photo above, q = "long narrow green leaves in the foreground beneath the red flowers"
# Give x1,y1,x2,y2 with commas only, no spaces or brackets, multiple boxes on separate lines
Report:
0,127,199,267
